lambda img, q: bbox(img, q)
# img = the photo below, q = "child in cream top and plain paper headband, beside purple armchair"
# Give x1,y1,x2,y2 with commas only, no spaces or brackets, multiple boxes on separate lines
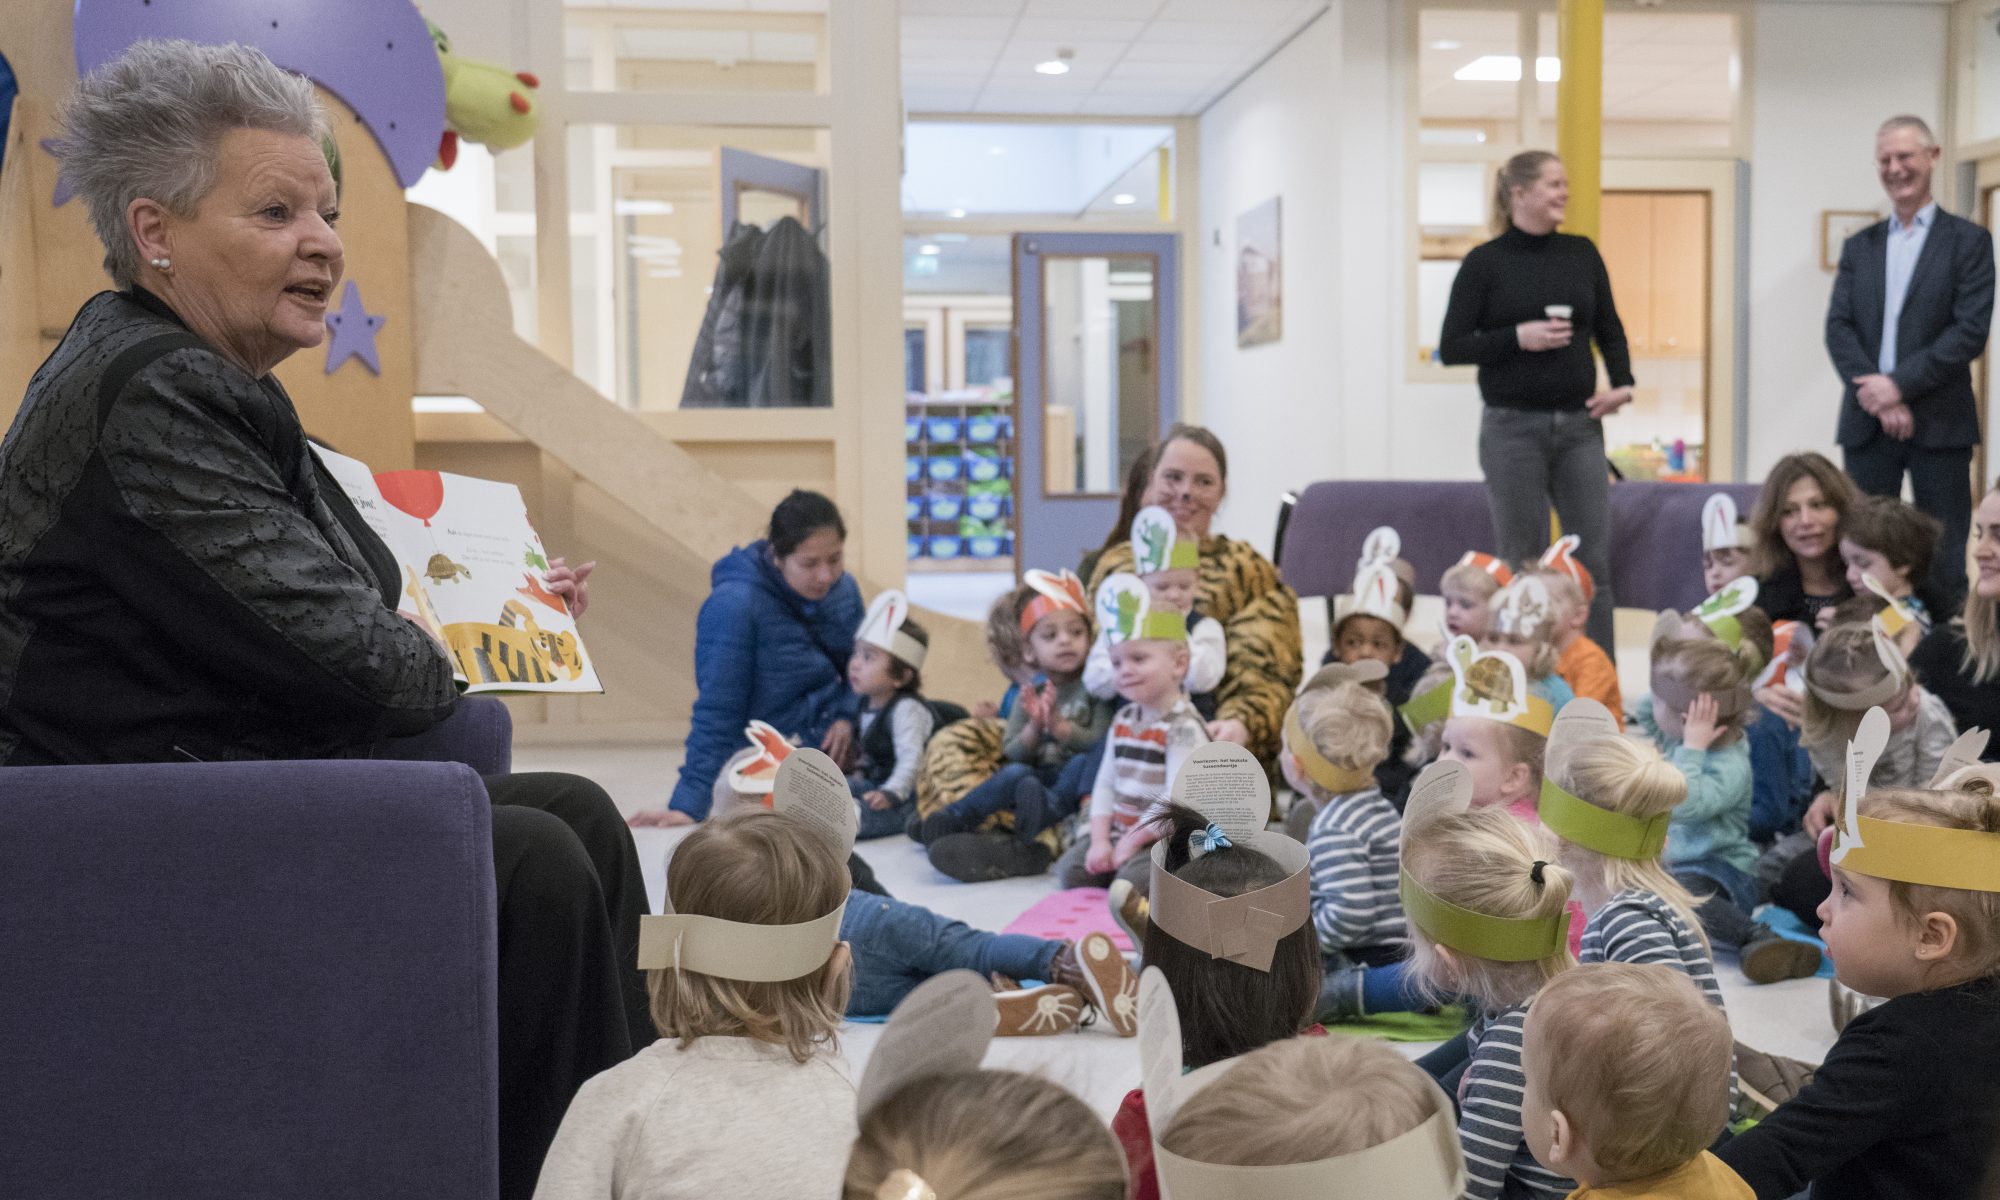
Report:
534,800,854,1200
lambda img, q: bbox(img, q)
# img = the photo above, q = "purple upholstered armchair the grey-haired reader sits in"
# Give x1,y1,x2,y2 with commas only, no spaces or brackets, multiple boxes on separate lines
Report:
0,700,508,1200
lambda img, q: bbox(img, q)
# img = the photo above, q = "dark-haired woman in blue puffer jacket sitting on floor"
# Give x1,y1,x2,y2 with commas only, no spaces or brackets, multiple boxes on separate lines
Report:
632,490,862,826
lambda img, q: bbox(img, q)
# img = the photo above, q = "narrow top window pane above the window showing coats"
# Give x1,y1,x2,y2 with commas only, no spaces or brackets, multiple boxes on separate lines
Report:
564,2,826,92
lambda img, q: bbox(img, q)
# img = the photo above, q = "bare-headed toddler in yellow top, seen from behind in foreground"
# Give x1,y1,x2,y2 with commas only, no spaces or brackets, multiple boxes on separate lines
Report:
1522,962,1756,1200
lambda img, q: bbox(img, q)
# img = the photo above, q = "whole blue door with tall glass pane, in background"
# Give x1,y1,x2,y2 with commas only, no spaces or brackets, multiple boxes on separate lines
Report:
1014,234,1180,574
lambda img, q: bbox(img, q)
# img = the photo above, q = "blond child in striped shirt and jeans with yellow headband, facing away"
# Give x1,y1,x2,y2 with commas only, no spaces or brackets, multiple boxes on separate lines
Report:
1278,664,1424,1022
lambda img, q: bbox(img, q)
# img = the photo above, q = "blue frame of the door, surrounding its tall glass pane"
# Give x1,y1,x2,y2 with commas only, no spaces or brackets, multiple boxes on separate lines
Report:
1014,234,1180,578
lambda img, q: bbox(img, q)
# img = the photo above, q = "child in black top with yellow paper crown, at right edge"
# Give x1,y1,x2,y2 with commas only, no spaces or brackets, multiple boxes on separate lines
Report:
1718,756,2000,1200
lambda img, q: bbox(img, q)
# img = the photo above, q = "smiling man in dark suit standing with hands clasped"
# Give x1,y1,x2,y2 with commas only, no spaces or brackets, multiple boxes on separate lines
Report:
1826,116,1994,598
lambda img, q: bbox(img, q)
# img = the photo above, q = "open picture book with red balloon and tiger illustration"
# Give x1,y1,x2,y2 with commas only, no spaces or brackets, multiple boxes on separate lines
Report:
314,446,604,692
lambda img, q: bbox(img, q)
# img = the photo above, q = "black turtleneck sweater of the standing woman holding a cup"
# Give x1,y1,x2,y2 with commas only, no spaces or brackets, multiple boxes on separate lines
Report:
1438,226,1632,412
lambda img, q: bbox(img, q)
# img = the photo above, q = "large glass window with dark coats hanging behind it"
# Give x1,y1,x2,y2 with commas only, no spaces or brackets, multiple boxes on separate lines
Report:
570,126,832,410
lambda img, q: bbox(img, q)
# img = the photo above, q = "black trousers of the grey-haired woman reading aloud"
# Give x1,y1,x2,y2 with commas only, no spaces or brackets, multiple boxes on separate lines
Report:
486,772,654,1200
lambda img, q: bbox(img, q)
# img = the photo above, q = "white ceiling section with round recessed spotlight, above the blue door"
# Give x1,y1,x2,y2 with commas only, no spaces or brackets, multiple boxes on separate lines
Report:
902,0,1326,116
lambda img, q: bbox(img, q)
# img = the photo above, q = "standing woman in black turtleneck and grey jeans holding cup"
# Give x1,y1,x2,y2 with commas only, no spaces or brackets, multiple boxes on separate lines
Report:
1438,150,1632,654
